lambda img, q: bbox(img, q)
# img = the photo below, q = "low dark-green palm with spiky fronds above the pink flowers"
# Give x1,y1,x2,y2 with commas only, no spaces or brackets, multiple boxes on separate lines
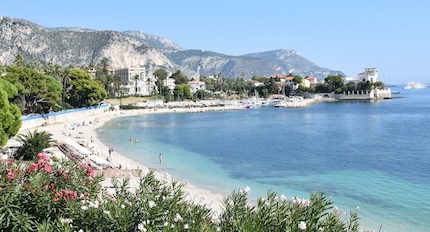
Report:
14,129,54,160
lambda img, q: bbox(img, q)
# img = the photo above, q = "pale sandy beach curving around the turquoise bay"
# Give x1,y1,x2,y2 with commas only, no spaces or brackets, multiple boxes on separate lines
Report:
19,107,245,213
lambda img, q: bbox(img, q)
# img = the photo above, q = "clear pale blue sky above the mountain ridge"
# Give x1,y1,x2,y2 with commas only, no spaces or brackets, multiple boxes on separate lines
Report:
0,0,430,84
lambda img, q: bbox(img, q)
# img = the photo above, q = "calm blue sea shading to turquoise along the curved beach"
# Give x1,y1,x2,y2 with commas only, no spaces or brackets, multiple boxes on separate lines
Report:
98,87,430,232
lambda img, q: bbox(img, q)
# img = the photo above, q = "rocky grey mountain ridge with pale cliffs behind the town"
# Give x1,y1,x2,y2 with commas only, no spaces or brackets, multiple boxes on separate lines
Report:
0,17,342,79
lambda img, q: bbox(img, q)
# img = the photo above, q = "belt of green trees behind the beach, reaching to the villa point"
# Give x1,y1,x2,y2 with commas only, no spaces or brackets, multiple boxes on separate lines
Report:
0,55,390,144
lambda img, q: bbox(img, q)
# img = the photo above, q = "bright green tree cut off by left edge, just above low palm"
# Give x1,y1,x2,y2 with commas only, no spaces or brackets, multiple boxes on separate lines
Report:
0,78,22,147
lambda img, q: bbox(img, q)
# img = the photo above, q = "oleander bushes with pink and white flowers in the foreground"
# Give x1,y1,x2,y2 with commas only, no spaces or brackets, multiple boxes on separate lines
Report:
0,153,358,231
